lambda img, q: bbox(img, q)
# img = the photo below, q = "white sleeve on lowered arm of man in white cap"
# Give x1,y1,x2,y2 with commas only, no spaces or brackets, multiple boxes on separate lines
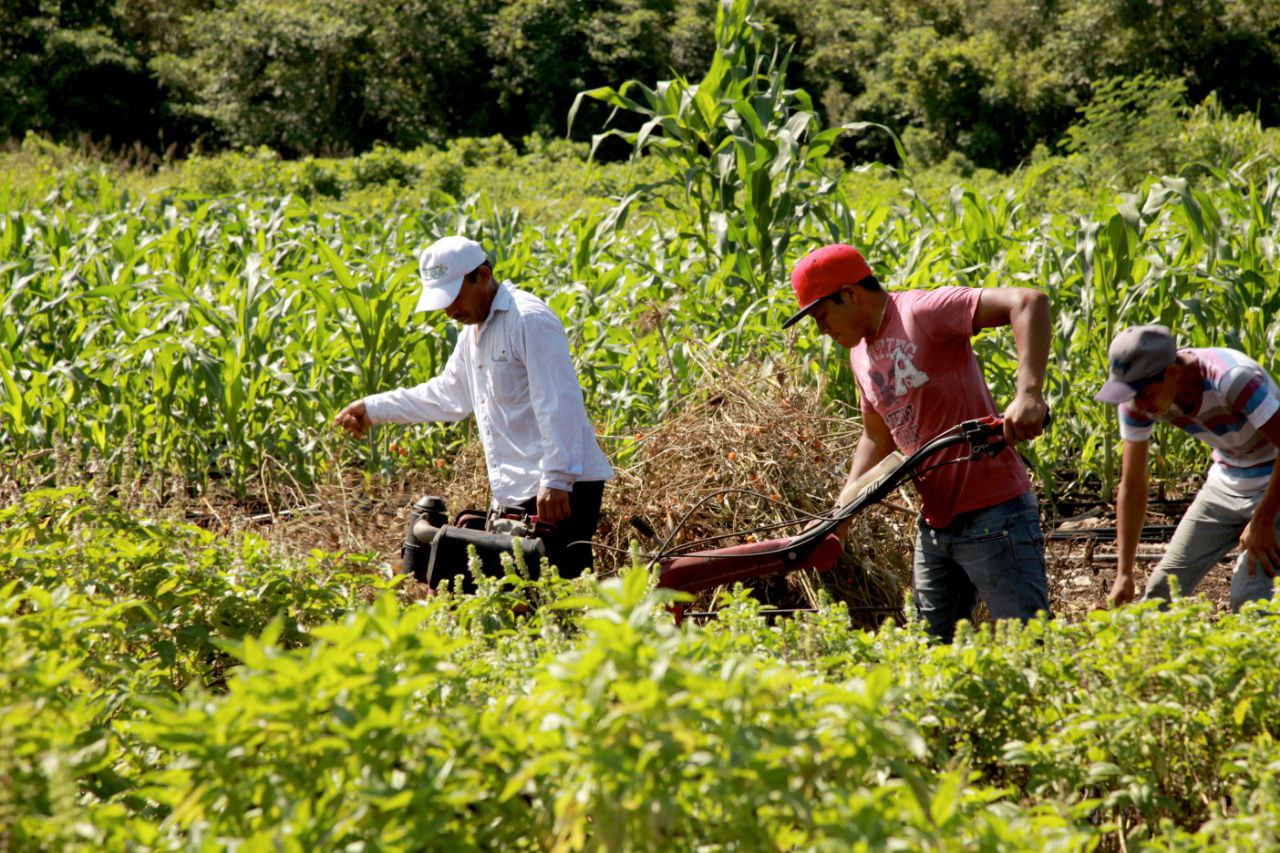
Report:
520,313,586,492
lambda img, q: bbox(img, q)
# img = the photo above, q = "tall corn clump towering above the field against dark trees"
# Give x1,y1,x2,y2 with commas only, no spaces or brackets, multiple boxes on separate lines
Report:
570,0,838,296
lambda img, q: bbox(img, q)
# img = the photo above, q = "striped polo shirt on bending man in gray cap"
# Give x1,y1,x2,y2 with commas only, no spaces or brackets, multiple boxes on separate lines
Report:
1119,348,1280,494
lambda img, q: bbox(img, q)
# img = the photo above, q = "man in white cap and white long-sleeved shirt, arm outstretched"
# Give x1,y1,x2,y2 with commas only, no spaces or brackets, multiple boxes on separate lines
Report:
333,236,613,576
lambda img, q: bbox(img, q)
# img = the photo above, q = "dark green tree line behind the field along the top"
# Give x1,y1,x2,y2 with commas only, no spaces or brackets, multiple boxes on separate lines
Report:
0,0,1280,169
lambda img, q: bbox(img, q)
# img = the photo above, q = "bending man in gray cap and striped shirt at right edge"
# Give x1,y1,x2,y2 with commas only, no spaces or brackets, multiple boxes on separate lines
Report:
1097,325,1280,610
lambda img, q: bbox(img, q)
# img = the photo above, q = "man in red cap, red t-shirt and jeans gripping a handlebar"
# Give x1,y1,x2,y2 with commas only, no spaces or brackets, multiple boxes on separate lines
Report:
783,243,1050,642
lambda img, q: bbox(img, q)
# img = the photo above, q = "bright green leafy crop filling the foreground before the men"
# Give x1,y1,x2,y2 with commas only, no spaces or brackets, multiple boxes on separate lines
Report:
0,491,1280,850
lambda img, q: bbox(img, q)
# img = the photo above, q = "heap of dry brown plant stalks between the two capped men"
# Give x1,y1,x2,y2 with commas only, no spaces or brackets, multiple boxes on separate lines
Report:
598,364,911,621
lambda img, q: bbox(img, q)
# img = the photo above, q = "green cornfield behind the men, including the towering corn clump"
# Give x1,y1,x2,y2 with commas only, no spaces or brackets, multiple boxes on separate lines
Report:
0,6,1280,492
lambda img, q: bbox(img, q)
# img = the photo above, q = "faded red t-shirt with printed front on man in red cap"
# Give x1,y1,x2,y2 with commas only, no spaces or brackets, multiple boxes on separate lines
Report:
849,287,1032,528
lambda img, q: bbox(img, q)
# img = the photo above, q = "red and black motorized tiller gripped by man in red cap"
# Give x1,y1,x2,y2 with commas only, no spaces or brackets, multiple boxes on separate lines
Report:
401,415,1048,612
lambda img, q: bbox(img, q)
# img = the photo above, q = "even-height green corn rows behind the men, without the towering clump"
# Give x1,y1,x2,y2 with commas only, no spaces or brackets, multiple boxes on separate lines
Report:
0,161,1280,493
